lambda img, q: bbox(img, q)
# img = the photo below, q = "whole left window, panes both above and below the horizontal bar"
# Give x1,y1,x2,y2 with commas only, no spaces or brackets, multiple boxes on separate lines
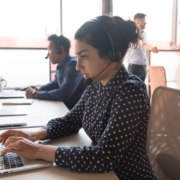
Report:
0,0,60,85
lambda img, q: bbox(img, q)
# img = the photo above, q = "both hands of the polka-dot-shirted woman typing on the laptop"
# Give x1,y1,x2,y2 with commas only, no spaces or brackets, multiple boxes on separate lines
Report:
0,129,54,162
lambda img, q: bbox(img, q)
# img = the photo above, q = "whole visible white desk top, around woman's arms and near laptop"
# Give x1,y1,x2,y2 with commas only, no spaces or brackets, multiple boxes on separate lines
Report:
0,93,118,180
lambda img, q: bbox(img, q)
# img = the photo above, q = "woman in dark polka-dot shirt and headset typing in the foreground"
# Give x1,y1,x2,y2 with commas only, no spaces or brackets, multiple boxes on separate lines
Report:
0,16,157,180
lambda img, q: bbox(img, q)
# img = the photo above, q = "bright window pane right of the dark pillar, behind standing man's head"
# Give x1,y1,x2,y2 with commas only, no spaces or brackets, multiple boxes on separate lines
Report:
113,0,173,49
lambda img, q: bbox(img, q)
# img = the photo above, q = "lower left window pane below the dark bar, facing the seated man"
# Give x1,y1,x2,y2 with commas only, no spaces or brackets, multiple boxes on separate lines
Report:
0,49,50,86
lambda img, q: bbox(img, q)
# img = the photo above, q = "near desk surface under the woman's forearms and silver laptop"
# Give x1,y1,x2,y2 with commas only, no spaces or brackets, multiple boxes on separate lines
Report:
0,128,118,180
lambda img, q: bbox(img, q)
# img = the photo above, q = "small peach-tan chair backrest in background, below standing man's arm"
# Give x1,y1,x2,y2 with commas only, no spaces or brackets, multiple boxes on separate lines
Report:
148,66,166,99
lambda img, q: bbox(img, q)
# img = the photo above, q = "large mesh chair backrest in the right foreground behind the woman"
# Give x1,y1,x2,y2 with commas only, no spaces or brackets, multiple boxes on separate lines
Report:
147,86,180,180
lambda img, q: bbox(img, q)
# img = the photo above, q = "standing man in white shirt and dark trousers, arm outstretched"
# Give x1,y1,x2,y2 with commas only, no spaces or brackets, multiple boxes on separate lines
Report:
125,13,158,81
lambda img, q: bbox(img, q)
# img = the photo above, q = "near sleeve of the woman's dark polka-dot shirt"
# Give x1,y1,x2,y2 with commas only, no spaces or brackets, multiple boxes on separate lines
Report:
55,85,147,172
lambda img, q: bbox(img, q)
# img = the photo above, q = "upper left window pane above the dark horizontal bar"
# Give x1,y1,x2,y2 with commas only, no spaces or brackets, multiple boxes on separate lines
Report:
0,0,60,47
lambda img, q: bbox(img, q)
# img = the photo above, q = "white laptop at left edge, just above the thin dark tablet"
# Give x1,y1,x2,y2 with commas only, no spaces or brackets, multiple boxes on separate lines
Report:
0,105,29,116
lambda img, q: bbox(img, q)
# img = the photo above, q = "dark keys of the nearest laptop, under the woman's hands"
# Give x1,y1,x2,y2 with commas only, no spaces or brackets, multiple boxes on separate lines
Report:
0,143,23,170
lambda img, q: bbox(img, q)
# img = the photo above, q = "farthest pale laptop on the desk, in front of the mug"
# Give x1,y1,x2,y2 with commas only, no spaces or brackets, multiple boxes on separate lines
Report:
0,90,25,99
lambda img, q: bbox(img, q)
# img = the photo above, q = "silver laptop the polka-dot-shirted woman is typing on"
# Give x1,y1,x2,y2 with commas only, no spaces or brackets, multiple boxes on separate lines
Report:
0,143,53,174
